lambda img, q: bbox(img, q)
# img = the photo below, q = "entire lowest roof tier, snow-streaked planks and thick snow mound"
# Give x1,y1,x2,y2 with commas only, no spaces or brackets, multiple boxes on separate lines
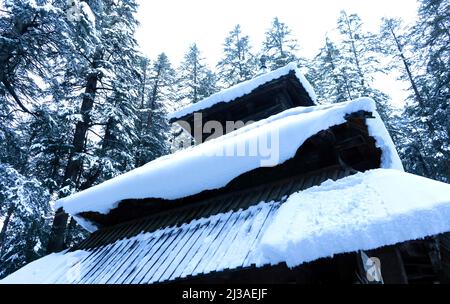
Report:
0,169,450,283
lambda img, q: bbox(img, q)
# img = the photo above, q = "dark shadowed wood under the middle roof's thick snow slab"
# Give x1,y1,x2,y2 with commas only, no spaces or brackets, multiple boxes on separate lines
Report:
80,112,381,227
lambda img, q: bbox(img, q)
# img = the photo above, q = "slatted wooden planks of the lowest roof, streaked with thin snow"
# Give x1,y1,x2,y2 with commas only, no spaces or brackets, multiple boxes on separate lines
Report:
55,166,351,284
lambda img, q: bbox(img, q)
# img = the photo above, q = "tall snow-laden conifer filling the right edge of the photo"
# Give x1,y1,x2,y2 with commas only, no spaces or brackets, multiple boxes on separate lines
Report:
392,0,450,182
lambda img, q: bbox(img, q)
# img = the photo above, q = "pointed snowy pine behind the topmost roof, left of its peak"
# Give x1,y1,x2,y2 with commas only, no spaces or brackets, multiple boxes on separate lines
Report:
217,24,257,87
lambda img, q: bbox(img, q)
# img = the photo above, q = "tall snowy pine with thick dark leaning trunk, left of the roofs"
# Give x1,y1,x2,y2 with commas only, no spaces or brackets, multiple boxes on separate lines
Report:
48,0,143,251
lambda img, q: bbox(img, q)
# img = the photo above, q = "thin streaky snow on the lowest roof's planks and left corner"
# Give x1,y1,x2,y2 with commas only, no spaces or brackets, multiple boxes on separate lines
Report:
0,202,279,284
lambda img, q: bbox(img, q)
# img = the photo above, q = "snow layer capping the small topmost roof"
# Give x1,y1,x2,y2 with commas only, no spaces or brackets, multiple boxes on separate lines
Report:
167,63,317,119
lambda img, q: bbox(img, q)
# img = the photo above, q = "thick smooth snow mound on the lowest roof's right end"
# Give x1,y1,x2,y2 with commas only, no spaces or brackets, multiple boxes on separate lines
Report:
260,169,450,267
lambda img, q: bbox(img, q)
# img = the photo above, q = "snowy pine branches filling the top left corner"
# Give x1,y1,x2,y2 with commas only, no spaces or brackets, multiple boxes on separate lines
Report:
0,0,68,114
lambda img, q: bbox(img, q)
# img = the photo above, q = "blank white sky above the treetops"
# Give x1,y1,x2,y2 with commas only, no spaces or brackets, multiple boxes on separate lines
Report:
136,0,417,105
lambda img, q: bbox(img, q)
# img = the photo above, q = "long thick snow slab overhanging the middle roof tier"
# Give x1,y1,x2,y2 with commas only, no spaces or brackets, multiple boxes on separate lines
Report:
56,98,403,231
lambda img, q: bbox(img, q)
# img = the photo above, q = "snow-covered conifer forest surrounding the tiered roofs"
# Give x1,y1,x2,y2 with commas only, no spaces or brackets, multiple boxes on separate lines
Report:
0,0,450,278
